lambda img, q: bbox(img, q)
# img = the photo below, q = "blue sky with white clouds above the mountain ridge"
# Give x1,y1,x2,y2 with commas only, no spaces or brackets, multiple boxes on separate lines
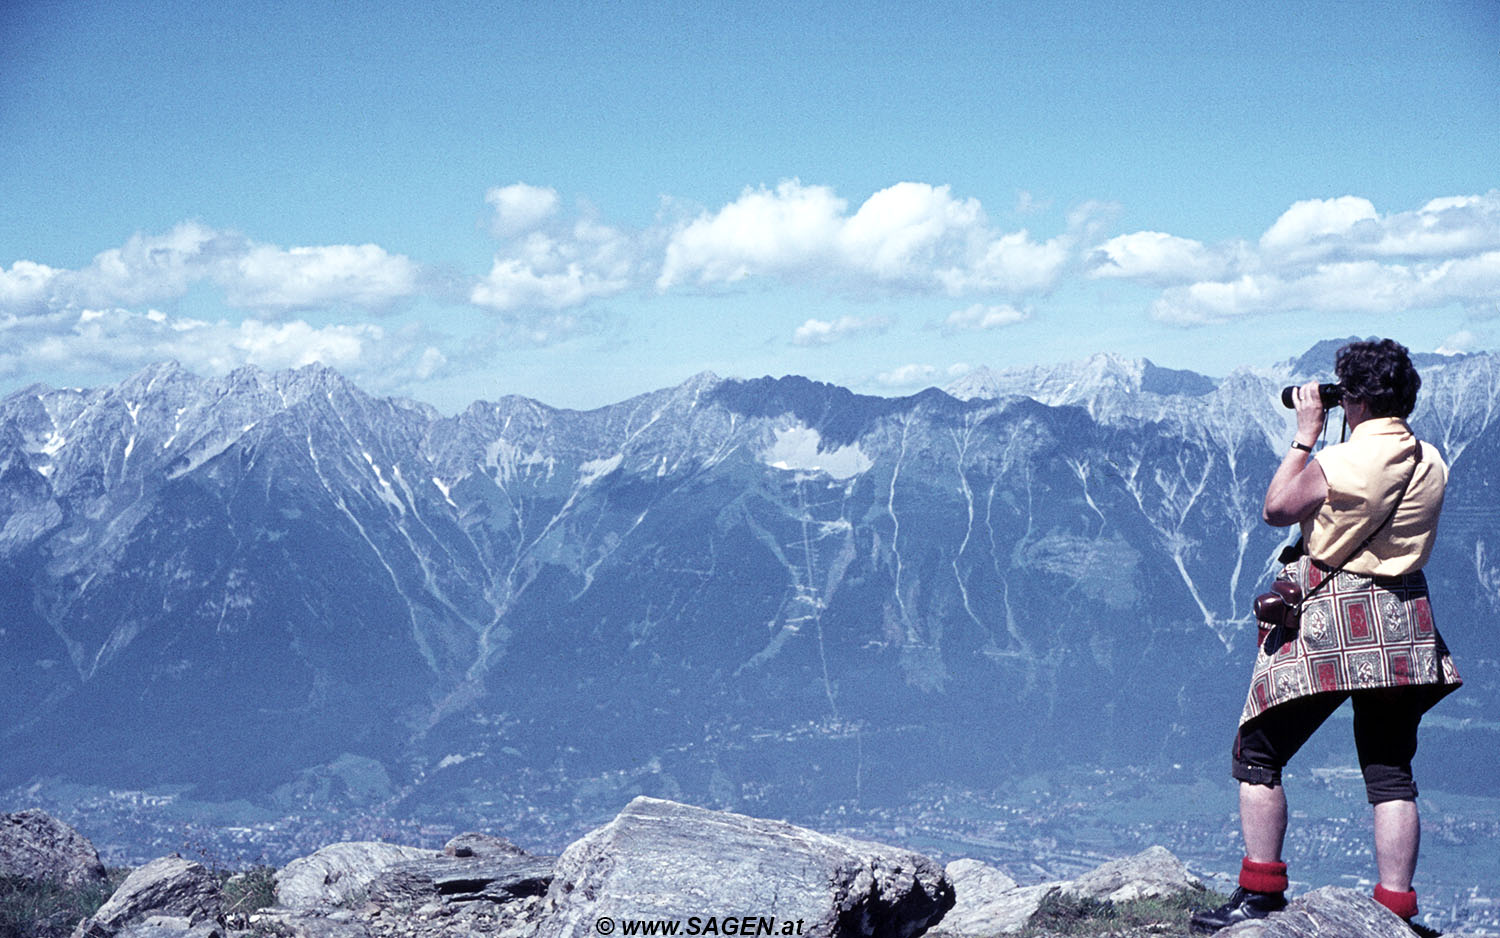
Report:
0,0,1500,413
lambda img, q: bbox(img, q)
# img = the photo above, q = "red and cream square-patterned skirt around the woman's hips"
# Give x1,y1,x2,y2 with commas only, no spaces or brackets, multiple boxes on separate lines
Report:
1239,557,1463,725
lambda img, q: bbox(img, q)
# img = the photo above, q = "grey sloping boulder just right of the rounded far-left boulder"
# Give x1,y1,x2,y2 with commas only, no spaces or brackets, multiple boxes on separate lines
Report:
74,857,224,938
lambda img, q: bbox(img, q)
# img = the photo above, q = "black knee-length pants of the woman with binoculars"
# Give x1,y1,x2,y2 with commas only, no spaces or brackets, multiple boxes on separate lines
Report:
1232,686,1452,804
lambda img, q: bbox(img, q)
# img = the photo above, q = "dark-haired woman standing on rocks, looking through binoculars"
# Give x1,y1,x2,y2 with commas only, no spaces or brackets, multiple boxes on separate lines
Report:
1193,339,1461,933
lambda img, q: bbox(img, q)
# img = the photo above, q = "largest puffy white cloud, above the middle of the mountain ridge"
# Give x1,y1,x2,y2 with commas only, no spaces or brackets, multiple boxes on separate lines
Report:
657,179,1073,294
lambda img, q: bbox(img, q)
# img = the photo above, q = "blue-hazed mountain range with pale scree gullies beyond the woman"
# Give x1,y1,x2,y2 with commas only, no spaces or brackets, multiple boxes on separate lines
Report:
0,342,1500,834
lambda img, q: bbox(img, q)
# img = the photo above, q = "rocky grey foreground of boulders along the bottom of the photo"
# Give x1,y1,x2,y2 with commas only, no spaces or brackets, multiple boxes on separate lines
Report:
0,798,1470,938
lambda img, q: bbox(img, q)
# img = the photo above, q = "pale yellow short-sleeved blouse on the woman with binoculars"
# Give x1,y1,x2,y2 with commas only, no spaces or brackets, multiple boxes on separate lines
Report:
1302,417,1448,576
